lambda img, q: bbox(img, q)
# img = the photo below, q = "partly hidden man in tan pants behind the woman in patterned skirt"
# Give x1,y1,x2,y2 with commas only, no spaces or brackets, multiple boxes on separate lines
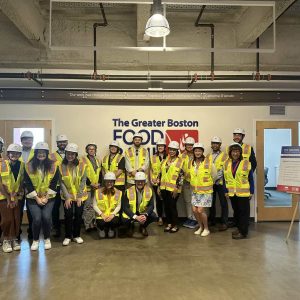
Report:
179,136,198,229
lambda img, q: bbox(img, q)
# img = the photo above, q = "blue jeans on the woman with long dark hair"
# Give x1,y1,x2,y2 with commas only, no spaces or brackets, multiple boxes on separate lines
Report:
26,199,54,241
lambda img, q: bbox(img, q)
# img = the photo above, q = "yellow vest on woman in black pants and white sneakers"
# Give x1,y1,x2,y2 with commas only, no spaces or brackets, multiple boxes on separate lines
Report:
59,161,88,201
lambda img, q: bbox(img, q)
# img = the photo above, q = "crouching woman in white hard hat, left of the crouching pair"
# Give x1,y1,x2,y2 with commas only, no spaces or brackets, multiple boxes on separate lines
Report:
93,172,122,238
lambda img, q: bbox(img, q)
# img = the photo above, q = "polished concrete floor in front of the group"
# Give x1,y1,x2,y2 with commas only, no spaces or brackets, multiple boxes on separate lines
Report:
0,223,300,300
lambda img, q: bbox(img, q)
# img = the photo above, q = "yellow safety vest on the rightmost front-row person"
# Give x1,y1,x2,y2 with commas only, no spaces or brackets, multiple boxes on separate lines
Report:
223,159,251,197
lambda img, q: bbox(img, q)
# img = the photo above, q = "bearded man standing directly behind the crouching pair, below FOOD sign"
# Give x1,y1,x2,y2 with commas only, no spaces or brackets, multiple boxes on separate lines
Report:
125,133,150,186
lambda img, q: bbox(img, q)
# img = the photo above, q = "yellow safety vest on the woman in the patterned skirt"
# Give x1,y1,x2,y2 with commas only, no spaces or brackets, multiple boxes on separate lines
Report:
188,157,214,194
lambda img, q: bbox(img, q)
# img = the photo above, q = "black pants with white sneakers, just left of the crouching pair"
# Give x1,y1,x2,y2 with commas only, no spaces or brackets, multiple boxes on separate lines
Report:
64,201,84,239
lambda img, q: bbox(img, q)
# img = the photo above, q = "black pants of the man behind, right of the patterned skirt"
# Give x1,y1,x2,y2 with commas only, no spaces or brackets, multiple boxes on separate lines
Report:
209,184,228,224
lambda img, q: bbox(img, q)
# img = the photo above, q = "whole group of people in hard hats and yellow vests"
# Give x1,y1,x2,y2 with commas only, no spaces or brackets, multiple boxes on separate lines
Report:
0,128,256,252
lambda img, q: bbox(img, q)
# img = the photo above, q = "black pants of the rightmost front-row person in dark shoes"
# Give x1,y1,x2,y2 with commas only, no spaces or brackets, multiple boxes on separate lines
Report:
230,196,250,236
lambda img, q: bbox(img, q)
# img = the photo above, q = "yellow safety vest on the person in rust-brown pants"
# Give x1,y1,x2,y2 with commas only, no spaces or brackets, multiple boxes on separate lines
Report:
0,160,25,201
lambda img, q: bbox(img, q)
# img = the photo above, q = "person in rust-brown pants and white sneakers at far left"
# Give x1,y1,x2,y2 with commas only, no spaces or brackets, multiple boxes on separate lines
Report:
0,144,24,253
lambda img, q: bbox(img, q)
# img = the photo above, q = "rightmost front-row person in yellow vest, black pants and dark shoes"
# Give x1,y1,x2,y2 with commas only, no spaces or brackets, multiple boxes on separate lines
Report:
223,143,254,240
